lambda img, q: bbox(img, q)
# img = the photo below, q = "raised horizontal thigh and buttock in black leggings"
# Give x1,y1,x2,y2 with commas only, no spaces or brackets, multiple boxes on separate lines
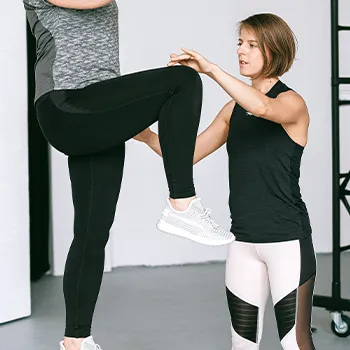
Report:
37,67,200,155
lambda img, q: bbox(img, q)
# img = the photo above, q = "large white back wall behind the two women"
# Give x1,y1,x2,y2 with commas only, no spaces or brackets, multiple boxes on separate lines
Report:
52,0,350,274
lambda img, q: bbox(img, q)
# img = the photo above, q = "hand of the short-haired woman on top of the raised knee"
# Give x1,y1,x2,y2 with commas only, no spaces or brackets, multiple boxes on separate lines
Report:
168,49,215,74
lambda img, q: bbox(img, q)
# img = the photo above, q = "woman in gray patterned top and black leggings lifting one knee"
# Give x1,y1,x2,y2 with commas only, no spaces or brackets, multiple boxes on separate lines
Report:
23,0,234,350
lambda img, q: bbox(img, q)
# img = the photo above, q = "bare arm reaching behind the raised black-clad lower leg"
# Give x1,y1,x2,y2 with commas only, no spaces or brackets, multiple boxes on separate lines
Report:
134,100,235,164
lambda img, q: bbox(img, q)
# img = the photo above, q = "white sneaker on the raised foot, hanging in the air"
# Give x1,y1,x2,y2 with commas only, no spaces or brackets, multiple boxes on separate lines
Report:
157,198,235,246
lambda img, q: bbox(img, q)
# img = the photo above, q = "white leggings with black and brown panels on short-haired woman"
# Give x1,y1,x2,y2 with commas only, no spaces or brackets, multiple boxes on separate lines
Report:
226,237,316,350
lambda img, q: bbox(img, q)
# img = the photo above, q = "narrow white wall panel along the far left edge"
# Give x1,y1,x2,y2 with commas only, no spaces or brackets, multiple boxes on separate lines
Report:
0,1,30,323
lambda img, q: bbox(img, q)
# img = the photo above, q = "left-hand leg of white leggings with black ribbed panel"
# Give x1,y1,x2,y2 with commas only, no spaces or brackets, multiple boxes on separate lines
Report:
226,241,269,349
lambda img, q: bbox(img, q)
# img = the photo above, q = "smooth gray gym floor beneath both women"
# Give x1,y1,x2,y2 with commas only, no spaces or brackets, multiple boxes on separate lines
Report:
0,254,350,350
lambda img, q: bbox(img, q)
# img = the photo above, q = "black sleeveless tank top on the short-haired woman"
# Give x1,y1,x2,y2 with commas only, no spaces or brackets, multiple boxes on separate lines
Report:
227,81,311,243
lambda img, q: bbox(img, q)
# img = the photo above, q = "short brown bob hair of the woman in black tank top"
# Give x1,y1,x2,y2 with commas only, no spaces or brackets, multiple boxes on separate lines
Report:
238,13,297,78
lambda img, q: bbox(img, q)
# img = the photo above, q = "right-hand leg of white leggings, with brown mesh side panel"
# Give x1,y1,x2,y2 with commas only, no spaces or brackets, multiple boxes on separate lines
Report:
258,237,316,349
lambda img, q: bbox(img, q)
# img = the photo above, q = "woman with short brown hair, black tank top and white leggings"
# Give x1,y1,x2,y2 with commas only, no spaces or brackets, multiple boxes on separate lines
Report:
136,13,316,350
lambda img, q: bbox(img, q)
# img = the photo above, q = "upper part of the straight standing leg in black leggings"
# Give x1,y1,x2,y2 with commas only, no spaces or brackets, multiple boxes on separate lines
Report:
68,144,125,245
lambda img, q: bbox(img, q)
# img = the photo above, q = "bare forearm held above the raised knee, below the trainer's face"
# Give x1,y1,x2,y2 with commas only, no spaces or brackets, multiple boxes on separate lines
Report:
208,65,268,116
